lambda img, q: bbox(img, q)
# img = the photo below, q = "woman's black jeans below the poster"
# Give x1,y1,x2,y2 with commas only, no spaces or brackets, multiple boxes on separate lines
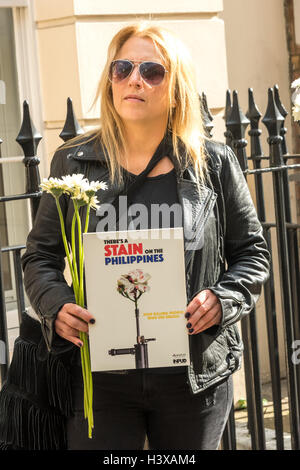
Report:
67,370,233,450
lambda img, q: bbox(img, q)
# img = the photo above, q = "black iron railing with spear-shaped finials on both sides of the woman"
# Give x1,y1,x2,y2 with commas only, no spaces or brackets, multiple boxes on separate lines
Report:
0,90,300,450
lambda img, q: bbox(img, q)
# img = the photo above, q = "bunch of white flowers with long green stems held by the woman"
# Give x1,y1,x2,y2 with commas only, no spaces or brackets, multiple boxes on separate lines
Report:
40,174,107,438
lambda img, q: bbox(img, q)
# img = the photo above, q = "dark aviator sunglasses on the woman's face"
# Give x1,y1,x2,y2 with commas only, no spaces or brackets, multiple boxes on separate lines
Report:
109,60,167,86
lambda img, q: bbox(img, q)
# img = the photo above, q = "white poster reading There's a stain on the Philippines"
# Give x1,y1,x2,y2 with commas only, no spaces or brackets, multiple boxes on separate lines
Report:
83,227,190,371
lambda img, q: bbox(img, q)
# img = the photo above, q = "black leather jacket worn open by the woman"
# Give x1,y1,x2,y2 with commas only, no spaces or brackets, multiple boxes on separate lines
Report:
22,135,269,393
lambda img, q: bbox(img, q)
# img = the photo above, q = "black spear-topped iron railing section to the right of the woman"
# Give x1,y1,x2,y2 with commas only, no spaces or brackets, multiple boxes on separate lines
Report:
216,86,300,450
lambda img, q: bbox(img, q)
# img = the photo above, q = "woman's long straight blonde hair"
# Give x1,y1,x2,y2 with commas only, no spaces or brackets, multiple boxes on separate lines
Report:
67,22,206,183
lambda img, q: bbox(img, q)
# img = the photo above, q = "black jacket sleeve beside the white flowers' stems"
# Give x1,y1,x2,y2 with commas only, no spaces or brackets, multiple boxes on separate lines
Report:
21,151,76,350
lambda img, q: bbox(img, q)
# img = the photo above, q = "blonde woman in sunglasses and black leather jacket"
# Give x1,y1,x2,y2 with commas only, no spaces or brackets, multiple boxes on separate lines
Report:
0,23,269,449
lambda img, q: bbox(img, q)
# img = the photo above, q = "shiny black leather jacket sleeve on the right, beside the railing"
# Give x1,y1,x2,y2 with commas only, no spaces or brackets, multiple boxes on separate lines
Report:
208,146,270,329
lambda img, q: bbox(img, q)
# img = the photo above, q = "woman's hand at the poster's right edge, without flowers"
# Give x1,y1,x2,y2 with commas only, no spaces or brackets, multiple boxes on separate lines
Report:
185,289,222,335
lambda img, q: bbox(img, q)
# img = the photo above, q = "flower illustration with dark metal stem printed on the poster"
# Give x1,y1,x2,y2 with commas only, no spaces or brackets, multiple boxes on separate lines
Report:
108,269,156,369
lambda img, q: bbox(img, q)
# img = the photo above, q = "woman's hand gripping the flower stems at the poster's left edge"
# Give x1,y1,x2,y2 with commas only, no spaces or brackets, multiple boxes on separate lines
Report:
54,303,95,348
